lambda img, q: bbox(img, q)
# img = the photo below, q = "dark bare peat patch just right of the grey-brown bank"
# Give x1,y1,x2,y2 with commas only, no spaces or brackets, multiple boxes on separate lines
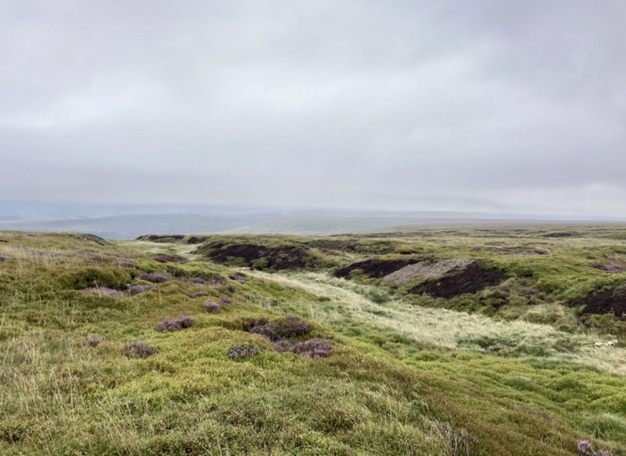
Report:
409,263,507,299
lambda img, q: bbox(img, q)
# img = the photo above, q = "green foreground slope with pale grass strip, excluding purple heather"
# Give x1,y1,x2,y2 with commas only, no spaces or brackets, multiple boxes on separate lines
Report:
0,233,626,455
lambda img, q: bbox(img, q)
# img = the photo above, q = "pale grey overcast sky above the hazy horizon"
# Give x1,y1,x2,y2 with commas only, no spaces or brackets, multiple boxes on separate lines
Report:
0,0,626,217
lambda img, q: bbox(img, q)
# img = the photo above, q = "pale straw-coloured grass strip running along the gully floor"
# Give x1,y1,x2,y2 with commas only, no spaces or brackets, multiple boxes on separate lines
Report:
250,272,626,375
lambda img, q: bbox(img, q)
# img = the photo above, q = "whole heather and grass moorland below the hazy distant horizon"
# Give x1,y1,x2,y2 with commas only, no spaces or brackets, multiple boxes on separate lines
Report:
0,226,626,455
